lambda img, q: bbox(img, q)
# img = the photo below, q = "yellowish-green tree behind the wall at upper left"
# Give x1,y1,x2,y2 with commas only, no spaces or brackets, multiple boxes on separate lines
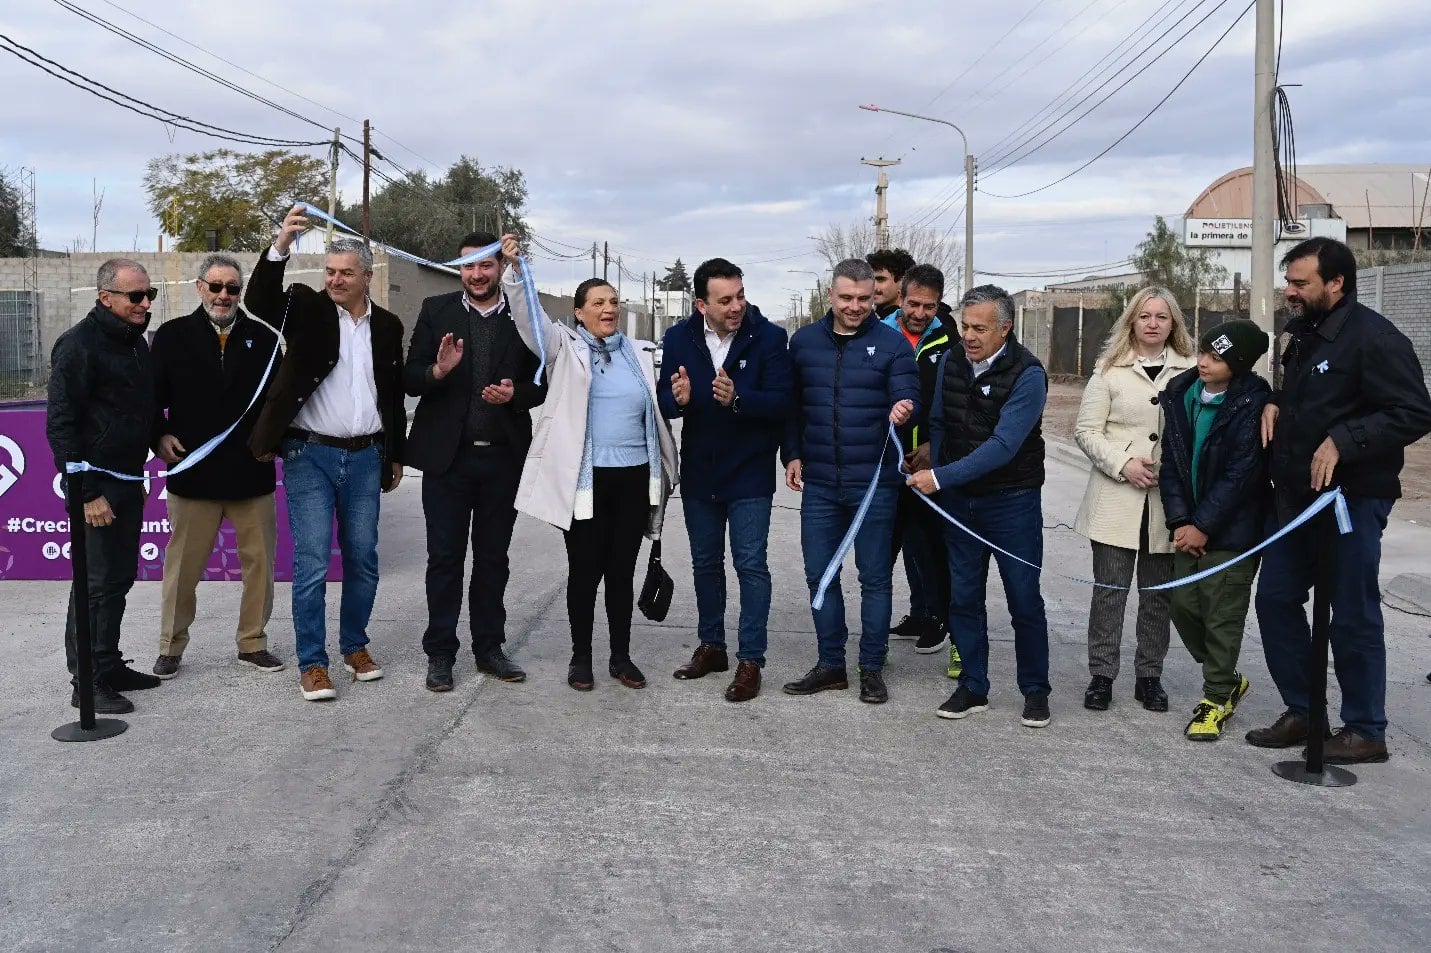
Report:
145,149,328,252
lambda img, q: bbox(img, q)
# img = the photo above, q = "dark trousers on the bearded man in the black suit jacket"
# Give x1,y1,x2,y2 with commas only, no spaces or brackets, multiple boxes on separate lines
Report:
422,445,522,660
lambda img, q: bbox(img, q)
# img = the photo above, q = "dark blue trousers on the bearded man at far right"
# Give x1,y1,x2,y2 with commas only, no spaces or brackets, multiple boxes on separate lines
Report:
1256,497,1394,741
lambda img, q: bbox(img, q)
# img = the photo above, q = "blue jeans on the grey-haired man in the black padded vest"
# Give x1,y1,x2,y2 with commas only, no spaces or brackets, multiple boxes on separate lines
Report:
936,489,1050,695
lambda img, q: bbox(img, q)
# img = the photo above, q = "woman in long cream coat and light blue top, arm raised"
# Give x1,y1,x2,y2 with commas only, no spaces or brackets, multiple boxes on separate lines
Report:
502,235,678,691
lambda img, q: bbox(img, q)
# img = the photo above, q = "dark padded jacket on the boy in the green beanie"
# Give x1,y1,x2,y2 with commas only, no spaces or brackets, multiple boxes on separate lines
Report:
1158,368,1272,552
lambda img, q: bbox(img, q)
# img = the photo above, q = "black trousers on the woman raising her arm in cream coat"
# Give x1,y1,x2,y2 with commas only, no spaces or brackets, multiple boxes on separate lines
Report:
565,464,651,661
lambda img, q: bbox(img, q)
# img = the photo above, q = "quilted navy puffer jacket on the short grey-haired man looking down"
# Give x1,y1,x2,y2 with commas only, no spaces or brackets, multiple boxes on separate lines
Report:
781,312,919,488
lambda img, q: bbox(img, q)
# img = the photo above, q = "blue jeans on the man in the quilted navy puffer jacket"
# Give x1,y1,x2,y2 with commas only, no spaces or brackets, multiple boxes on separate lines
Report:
800,482,899,671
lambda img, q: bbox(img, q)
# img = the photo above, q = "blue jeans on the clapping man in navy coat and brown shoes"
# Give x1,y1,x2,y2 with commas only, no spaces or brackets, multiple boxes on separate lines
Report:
681,497,771,667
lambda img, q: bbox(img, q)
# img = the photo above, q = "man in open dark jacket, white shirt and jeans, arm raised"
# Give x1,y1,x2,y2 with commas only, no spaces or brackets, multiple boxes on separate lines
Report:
243,206,408,701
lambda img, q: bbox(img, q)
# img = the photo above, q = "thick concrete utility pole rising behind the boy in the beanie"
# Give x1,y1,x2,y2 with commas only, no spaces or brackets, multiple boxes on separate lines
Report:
1248,0,1276,339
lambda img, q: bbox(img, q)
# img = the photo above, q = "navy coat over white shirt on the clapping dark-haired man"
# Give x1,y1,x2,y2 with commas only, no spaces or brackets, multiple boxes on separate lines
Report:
655,305,790,502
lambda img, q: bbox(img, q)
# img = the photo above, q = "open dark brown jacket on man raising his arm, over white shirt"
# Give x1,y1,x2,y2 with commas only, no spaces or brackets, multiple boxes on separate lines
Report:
243,249,408,489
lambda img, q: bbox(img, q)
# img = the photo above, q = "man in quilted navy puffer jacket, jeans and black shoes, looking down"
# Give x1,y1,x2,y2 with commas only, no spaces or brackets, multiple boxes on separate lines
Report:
781,259,919,704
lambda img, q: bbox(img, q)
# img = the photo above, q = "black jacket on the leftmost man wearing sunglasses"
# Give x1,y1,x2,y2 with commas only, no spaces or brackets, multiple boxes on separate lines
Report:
44,302,157,502
